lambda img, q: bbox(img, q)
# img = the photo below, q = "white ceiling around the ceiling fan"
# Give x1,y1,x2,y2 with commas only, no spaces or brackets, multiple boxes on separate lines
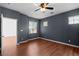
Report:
0,3,79,19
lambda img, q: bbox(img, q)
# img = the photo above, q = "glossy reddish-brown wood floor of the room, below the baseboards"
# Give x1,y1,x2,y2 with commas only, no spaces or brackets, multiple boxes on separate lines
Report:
3,39,79,56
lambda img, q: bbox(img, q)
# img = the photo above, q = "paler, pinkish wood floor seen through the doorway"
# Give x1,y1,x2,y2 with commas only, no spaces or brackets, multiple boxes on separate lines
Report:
2,36,17,55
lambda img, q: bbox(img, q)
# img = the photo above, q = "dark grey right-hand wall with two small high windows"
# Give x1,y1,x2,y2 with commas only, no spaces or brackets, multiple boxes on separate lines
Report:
40,9,79,46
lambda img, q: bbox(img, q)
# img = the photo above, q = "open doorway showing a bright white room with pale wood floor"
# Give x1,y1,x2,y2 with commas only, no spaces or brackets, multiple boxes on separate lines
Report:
1,15,17,55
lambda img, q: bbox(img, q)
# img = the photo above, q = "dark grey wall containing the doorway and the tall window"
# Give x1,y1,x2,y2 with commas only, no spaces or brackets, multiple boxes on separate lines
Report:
0,7,39,46
